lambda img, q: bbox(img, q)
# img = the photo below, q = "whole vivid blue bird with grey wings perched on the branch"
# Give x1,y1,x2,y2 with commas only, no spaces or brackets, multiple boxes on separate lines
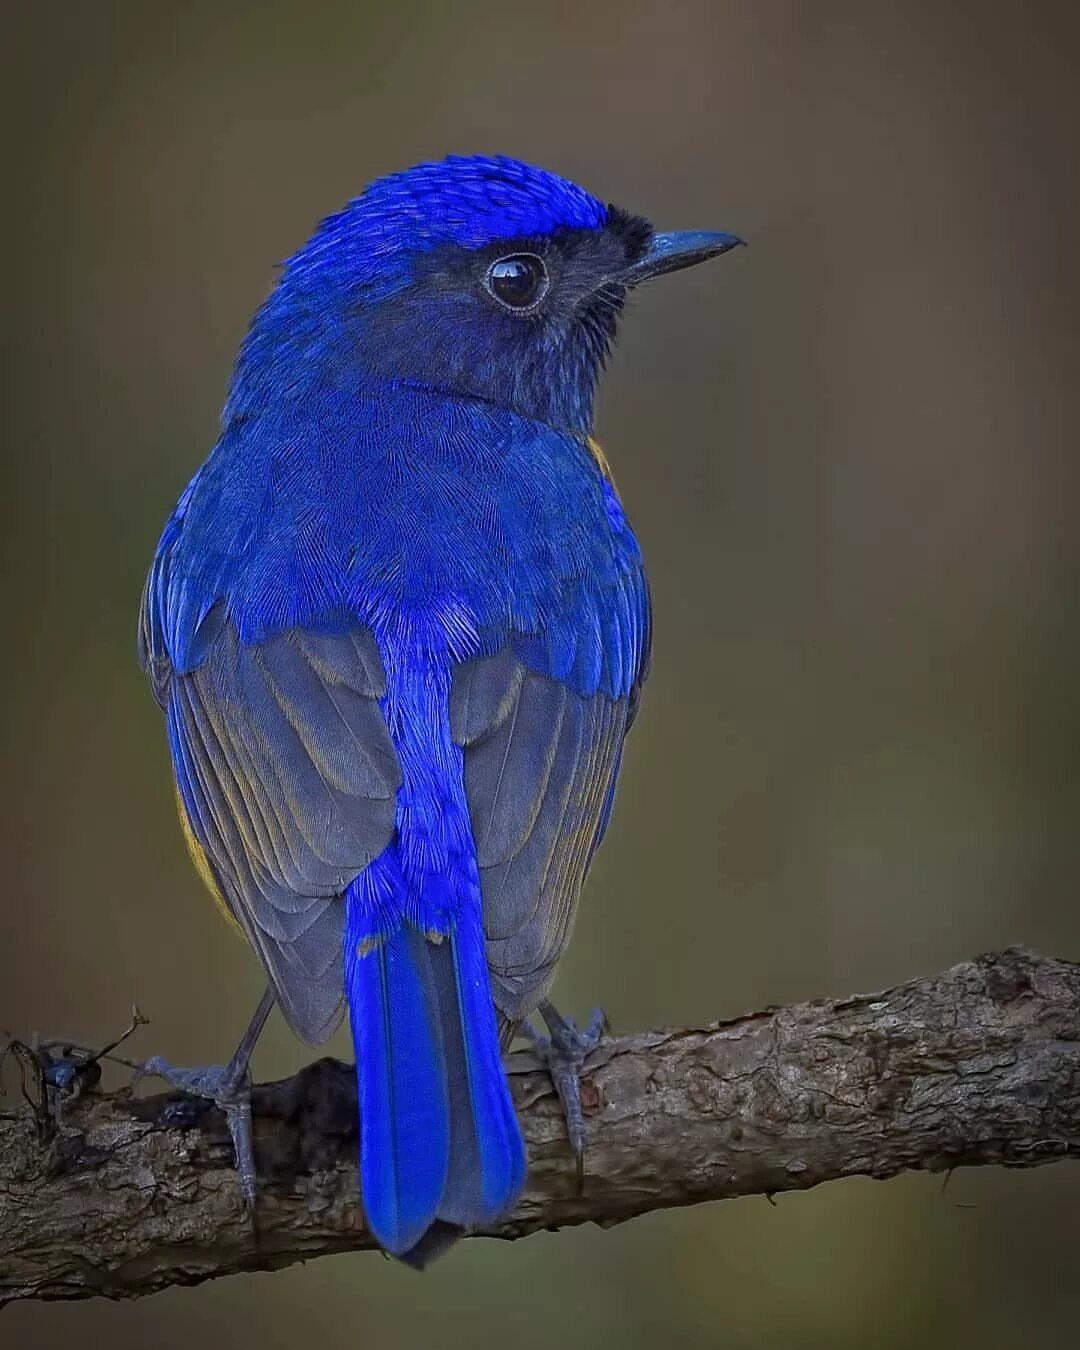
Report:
139,155,741,1268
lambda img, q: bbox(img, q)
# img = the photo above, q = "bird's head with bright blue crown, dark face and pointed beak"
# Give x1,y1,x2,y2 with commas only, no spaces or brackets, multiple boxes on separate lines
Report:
227,157,740,432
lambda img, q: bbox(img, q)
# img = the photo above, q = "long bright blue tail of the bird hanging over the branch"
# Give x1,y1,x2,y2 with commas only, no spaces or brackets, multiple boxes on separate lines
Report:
346,864,525,1266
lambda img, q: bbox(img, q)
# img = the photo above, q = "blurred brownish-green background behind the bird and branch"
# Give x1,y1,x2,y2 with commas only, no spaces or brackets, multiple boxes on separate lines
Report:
0,0,1080,1350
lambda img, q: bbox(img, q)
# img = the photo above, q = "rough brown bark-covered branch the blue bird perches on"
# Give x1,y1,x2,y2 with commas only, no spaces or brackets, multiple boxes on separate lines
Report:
0,948,1080,1303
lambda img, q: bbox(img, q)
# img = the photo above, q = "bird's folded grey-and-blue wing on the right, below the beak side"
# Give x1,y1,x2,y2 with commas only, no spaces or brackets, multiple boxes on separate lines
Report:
451,553,649,1021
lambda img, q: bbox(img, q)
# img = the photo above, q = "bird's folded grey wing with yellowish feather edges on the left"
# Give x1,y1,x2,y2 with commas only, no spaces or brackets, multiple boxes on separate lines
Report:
140,526,401,1044
